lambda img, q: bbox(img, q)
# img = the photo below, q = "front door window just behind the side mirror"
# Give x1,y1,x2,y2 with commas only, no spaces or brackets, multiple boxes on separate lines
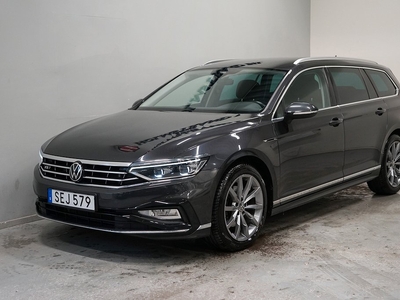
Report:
275,69,331,118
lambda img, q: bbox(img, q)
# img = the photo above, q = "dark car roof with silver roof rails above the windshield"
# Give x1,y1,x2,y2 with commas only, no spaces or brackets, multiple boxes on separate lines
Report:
195,57,383,70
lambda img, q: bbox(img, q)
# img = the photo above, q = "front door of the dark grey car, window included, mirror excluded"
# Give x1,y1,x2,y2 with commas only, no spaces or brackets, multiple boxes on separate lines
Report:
275,68,344,205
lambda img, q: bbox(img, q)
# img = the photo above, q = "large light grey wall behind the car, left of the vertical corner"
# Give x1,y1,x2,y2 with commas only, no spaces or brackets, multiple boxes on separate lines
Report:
0,0,310,224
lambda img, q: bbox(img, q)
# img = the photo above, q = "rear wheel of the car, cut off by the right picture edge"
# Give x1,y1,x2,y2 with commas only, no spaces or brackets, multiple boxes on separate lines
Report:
368,135,400,195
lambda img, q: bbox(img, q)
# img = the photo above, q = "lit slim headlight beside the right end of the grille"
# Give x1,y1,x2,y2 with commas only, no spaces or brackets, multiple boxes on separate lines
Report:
129,157,207,181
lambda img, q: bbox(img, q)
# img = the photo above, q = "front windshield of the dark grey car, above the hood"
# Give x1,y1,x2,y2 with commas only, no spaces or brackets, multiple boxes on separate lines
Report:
138,68,286,113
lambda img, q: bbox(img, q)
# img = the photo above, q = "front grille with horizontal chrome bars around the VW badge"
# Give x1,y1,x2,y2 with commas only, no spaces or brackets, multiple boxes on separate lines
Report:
40,155,146,188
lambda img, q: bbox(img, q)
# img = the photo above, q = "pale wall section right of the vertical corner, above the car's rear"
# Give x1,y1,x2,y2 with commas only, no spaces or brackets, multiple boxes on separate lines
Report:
311,0,400,79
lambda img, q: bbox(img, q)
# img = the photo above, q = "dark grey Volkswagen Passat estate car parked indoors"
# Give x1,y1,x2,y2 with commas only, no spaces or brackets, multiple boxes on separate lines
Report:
34,58,400,251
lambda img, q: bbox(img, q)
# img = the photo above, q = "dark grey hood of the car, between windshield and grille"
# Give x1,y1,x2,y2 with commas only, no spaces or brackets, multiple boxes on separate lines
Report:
42,110,248,162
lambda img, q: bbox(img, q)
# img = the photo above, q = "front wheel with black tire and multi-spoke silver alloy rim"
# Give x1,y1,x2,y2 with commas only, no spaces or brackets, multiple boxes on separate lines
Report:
208,164,267,252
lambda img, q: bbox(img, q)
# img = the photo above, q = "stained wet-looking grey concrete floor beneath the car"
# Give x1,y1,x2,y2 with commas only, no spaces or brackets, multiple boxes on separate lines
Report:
0,185,400,300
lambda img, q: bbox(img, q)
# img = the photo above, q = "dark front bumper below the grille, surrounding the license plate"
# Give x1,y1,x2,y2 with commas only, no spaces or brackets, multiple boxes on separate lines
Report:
33,166,214,239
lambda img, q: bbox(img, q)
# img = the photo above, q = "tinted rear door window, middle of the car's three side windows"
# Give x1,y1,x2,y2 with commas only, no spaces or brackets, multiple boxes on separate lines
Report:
330,68,369,104
